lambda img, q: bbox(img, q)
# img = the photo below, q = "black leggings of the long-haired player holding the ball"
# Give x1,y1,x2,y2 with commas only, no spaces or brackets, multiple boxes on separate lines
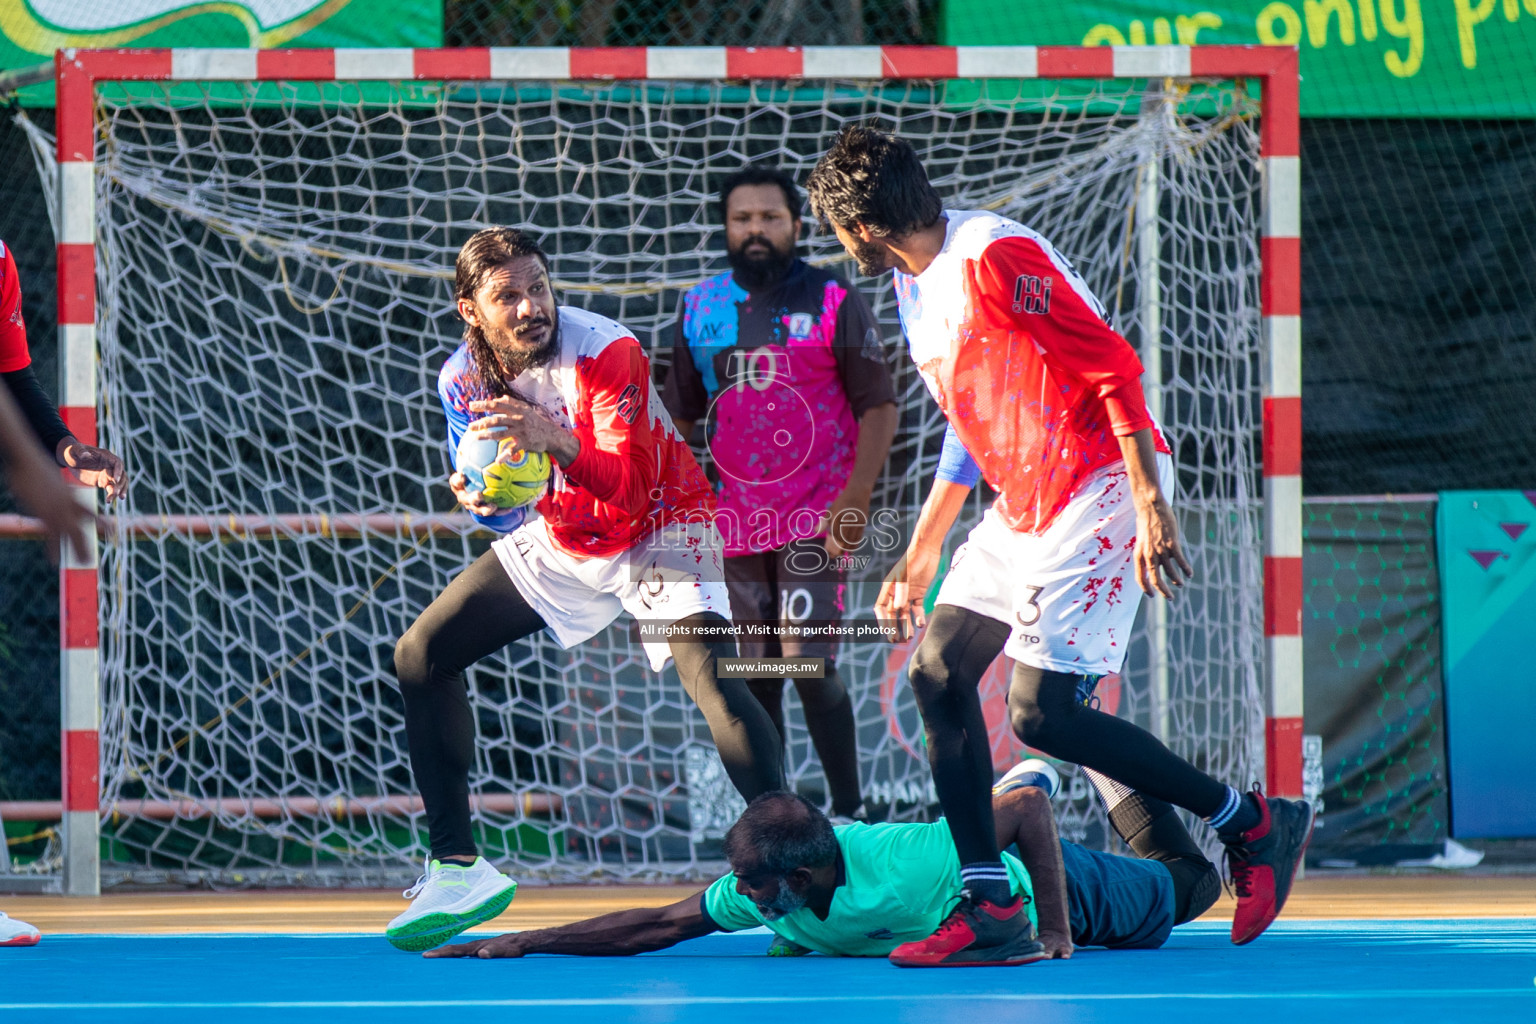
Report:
395,551,783,860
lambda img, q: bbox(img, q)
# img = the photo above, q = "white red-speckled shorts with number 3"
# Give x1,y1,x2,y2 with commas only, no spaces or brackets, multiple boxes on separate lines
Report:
935,451,1174,676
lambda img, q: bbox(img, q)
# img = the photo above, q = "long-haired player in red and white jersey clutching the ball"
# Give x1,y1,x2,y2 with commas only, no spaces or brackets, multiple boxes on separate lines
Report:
387,227,783,949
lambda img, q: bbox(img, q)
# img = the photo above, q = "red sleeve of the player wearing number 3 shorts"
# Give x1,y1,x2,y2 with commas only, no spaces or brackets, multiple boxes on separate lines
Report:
974,236,1152,438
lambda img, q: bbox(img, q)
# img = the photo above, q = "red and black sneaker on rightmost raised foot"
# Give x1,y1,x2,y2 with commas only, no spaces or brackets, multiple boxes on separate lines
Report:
1226,786,1312,946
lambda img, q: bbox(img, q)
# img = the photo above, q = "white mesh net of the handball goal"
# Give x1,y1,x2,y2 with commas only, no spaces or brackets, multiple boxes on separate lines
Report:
59,81,1263,884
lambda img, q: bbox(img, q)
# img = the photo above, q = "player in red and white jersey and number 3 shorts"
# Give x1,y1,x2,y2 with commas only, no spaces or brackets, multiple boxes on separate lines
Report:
806,126,1312,966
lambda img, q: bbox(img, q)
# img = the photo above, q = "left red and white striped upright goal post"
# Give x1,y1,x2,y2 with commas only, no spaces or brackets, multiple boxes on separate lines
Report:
55,51,101,897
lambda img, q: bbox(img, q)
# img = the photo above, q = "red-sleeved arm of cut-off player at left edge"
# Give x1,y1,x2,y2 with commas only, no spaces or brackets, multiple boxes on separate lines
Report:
0,241,127,502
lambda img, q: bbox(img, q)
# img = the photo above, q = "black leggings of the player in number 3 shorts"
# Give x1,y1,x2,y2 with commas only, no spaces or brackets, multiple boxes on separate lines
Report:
908,605,1227,864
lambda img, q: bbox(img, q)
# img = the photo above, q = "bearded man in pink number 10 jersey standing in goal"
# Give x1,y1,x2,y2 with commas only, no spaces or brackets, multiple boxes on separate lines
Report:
662,163,897,821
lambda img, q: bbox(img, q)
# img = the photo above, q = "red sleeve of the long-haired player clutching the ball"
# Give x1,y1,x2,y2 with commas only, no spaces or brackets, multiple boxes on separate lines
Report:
565,338,660,516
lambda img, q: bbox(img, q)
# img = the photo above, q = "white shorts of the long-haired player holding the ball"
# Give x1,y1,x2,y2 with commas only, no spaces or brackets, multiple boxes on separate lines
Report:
490,517,731,672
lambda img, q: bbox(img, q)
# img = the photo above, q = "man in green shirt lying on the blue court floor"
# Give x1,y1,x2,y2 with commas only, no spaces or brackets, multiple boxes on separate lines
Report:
425,772,1221,966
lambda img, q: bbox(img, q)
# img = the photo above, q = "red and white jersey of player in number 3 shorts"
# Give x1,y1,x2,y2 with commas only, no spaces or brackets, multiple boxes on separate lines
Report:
894,210,1167,540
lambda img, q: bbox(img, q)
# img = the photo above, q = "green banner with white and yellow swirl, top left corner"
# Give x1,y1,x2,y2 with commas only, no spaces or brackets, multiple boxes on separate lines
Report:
0,0,445,106
